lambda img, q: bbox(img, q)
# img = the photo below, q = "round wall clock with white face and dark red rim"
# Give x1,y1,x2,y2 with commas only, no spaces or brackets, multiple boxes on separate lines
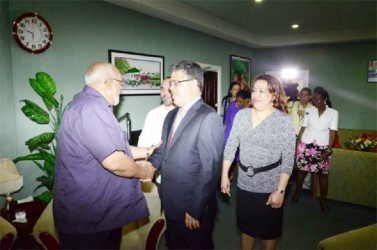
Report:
13,13,52,54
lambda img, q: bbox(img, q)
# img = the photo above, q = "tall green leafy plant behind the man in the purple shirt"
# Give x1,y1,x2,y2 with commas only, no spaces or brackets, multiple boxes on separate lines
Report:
13,72,65,203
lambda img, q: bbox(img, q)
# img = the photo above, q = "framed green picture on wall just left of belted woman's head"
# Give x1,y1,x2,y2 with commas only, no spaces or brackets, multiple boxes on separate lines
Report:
229,55,251,89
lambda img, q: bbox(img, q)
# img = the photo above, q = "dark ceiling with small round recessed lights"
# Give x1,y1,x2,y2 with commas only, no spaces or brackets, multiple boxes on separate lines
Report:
104,0,377,48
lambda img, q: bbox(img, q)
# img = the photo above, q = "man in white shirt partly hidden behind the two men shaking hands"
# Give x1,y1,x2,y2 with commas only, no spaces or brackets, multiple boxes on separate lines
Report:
137,77,175,183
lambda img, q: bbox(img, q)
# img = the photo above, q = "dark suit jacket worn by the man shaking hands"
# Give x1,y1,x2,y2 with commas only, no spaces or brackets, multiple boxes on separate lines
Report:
148,99,224,221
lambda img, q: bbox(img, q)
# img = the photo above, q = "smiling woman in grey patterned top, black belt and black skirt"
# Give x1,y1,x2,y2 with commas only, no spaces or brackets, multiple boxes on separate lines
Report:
221,75,295,249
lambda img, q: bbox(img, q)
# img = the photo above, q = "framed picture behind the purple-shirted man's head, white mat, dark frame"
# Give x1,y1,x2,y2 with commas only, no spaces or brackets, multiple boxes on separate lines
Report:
109,50,165,95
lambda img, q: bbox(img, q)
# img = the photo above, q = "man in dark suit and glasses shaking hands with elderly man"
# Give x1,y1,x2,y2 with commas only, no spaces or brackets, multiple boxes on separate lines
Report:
148,61,224,249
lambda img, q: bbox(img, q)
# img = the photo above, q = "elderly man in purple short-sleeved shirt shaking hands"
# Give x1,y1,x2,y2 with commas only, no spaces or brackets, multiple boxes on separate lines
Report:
53,62,155,249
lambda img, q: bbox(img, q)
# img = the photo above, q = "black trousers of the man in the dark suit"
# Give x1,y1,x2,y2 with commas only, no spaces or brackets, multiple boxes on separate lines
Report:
166,207,217,249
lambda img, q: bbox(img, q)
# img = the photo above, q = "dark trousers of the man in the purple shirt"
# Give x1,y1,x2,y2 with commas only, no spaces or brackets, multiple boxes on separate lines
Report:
59,228,122,249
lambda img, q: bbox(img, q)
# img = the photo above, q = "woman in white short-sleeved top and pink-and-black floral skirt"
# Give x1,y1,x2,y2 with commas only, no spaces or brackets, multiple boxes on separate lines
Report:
292,87,338,212
